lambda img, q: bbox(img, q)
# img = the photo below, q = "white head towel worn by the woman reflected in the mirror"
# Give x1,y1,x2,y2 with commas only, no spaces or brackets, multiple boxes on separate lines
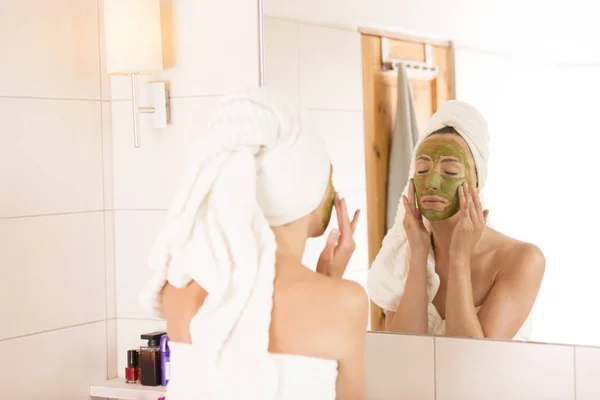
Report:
367,100,489,312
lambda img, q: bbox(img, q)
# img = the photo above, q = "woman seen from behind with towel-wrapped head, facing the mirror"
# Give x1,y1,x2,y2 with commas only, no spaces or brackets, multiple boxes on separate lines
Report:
142,88,368,400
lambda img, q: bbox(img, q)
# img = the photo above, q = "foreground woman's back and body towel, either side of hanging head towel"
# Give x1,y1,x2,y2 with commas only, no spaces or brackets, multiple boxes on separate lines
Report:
162,262,368,400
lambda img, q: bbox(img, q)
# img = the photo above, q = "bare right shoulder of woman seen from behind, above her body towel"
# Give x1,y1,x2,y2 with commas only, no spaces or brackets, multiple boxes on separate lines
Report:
271,265,369,360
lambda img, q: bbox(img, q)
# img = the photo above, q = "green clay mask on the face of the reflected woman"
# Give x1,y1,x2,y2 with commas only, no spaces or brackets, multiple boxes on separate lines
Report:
413,135,473,221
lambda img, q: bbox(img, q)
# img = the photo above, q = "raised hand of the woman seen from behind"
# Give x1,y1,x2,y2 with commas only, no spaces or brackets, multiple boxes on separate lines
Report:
317,194,360,278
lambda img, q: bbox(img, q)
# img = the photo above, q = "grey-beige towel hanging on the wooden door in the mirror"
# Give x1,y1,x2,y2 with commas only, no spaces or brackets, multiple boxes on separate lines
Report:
386,64,419,230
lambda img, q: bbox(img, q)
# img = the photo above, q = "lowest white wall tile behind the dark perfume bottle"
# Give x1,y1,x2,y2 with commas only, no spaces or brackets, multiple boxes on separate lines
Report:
117,318,167,377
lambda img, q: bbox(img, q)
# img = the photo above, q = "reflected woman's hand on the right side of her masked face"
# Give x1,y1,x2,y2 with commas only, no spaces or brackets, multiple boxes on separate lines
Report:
450,183,489,260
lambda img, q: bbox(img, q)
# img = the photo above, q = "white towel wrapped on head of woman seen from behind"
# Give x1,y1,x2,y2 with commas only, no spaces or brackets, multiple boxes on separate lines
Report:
140,88,330,400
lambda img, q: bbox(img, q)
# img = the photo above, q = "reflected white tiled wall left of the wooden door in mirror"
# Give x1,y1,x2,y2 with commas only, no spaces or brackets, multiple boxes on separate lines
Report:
264,17,369,300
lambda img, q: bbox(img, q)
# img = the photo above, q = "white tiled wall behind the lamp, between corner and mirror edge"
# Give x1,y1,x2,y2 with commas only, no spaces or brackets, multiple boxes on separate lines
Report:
111,0,259,377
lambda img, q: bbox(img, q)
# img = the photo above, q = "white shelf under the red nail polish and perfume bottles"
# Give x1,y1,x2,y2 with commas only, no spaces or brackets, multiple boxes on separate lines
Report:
90,378,167,400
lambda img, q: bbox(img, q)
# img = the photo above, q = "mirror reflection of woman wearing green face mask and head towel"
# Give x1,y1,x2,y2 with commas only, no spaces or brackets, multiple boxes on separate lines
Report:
368,101,545,339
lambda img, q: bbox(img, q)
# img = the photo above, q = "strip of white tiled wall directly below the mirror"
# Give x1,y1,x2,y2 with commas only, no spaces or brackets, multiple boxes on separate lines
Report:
365,333,600,400
